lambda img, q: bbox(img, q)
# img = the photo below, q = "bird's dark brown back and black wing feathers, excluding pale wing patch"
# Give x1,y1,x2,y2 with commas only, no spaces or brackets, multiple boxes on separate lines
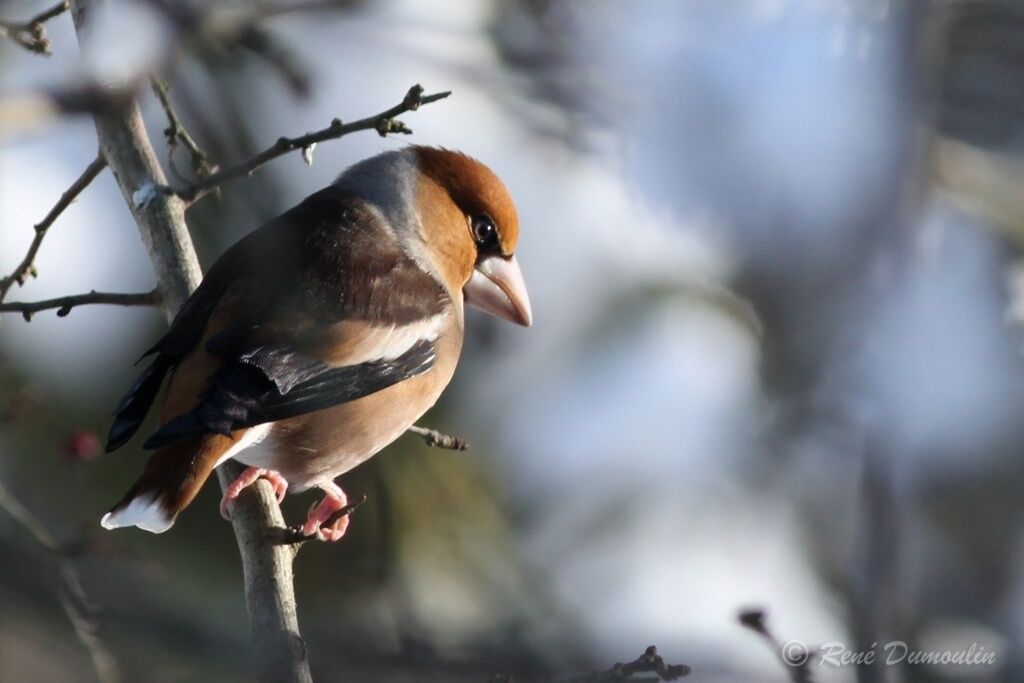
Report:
106,185,447,451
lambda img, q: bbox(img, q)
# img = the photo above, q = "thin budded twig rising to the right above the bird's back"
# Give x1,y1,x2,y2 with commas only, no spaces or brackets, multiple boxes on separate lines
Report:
161,85,452,204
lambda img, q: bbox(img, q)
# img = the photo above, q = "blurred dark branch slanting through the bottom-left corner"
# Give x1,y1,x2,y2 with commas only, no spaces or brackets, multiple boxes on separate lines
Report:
0,484,121,683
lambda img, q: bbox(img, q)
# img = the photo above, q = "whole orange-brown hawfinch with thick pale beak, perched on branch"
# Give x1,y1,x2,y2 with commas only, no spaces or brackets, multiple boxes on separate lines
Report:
101,146,531,541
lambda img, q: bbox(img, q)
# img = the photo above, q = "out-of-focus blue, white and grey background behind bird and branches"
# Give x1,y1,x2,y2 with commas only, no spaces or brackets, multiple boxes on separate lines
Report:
0,0,1024,682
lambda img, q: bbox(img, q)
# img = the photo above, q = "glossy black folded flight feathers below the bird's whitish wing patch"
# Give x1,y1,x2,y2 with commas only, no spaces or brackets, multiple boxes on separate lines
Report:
142,340,436,449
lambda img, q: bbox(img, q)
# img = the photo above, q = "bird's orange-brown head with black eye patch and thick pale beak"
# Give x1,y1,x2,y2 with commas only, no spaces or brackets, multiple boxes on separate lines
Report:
412,146,532,327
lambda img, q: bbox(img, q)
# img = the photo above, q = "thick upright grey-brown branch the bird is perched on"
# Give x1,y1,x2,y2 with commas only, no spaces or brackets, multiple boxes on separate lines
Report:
73,0,312,683
